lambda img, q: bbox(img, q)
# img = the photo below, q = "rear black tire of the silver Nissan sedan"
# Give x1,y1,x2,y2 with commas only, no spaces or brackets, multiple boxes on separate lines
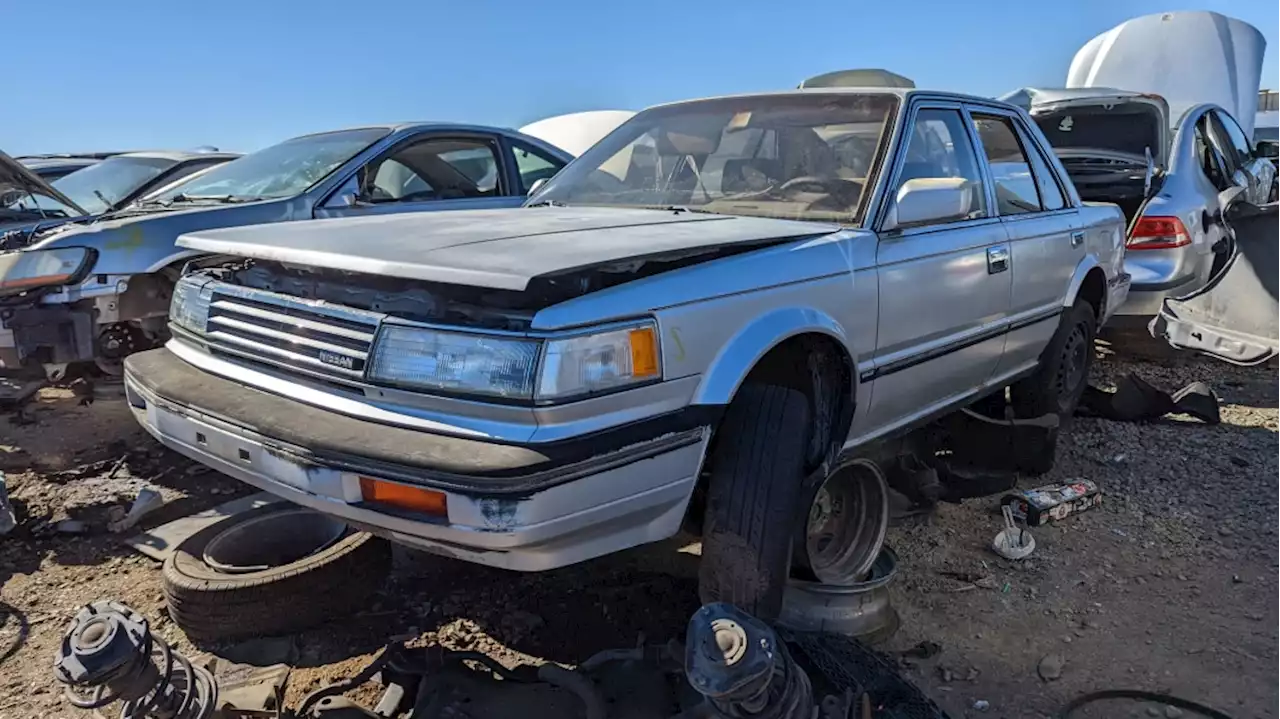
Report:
1009,299,1098,423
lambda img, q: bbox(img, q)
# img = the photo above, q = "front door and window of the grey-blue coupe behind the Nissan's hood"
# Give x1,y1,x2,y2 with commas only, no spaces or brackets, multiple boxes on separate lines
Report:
315,136,524,217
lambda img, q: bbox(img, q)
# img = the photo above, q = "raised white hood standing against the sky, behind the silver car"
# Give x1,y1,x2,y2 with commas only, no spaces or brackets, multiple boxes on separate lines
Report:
1066,12,1267,137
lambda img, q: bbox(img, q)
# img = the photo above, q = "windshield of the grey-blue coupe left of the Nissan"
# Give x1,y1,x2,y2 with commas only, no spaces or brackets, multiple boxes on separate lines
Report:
152,128,390,202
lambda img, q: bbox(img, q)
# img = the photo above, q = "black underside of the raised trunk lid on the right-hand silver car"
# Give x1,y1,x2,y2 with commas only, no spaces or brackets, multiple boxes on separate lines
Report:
1032,102,1164,159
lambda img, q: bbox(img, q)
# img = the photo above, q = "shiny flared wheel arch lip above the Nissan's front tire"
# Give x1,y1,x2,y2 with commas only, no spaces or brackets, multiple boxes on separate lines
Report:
692,307,854,404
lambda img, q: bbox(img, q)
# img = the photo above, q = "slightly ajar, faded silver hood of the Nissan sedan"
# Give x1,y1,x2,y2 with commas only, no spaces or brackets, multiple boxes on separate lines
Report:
178,207,840,290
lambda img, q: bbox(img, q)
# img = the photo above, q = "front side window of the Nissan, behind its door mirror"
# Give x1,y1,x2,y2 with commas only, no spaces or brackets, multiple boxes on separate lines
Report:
893,109,987,217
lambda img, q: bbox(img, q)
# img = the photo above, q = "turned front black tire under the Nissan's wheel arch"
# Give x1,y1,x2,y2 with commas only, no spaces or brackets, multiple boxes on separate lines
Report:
698,384,812,622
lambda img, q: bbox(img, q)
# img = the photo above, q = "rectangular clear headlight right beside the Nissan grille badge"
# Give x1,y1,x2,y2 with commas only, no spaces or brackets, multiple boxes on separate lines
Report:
367,324,539,399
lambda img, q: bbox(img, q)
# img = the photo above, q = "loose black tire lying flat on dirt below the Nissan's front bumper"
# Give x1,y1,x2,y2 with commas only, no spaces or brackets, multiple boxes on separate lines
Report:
163,504,392,641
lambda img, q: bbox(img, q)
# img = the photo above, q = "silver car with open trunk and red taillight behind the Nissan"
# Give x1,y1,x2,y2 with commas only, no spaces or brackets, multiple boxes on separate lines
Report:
1005,88,1277,324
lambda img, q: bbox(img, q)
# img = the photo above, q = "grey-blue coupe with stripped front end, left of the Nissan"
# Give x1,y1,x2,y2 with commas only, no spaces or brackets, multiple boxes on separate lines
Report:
0,123,571,376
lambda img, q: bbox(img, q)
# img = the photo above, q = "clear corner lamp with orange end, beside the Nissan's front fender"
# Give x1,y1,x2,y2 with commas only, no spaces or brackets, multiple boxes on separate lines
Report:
536,321,662,402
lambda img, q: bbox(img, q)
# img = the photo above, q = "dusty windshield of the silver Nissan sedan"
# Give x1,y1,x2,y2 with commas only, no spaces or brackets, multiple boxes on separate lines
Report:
530,93,897,224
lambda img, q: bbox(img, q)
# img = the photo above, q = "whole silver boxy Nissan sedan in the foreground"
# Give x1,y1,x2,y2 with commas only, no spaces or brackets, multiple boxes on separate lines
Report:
124,88,1128,617
